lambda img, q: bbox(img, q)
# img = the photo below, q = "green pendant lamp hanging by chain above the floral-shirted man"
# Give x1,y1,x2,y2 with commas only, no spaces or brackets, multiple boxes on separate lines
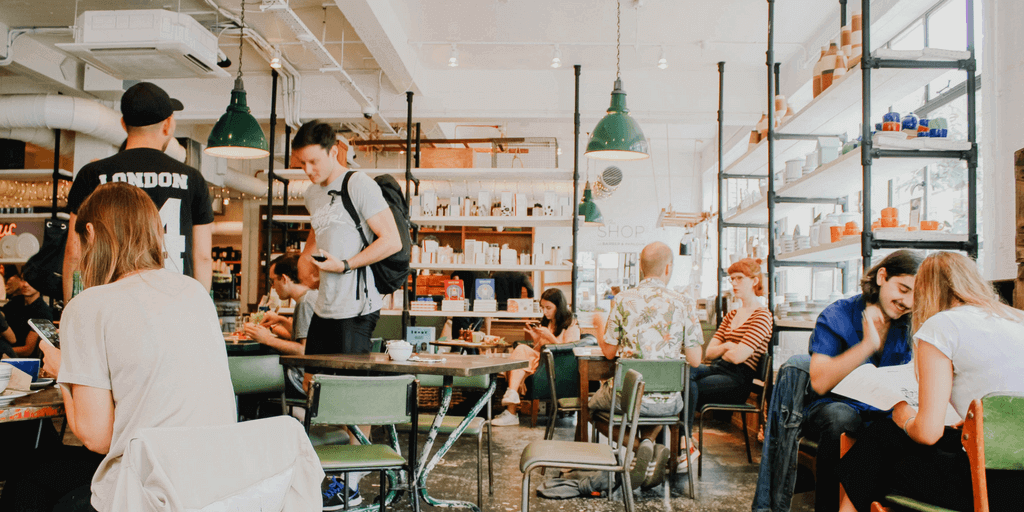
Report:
586,0,650,161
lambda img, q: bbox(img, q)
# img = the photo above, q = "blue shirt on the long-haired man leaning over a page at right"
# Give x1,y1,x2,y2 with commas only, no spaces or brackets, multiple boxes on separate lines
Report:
810,295,911,413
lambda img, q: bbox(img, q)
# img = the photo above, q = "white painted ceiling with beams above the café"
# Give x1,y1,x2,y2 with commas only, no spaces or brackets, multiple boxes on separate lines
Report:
0,0,937,206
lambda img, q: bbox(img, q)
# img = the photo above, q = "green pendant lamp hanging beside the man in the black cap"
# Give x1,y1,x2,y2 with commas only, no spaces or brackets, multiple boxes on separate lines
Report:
203,2,270,160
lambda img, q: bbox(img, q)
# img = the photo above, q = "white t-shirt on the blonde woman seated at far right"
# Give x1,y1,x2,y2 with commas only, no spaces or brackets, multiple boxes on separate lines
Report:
913,306,1024,418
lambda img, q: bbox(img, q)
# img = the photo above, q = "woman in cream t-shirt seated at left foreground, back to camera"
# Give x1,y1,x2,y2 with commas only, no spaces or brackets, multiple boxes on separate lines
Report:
0,183,236,512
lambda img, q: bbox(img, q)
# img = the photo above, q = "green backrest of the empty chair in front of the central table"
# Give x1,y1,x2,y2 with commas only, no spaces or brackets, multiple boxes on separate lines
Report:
307,375,418,426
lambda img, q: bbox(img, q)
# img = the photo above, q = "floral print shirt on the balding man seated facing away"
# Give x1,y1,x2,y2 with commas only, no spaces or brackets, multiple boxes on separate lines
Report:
604,278,703,401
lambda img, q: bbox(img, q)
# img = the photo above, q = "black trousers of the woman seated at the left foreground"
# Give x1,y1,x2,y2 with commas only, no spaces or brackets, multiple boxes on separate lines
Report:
0,446,103,512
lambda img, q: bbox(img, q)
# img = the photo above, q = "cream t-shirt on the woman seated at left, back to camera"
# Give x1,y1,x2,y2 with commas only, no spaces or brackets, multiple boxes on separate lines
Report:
57,269,236,512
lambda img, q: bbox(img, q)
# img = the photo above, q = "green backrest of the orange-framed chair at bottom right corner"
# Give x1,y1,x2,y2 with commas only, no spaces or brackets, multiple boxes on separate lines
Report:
981,394,1024,470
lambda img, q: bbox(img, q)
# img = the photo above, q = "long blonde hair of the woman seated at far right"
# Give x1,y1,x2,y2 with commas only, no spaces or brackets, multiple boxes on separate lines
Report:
913,251,1024,332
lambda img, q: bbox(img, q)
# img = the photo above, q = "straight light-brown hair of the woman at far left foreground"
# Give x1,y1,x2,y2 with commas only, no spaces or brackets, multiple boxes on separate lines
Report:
75,182,164,288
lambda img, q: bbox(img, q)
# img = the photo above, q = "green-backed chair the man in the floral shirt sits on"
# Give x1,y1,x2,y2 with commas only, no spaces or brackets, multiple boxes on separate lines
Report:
593,357,696,501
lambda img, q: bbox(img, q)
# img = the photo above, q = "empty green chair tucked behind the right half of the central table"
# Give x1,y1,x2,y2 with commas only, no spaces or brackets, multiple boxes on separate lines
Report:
394,375,495,508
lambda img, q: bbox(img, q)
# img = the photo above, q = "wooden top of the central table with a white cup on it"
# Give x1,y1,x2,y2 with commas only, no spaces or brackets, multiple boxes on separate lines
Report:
281,353,529,377
